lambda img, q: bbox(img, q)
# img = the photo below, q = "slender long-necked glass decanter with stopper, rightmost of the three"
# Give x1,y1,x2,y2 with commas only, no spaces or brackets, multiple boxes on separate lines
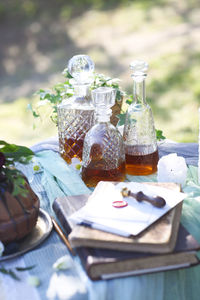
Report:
123,60,158,175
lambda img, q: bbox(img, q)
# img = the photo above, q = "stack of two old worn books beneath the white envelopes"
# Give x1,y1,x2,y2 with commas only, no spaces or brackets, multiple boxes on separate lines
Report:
53,183,200,280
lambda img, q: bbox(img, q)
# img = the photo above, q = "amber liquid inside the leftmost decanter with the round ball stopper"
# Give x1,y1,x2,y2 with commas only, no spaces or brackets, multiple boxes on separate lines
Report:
61,138,84,164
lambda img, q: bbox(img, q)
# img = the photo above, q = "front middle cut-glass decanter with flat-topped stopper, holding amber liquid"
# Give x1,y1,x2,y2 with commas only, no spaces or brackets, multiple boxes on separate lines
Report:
82,87,125,187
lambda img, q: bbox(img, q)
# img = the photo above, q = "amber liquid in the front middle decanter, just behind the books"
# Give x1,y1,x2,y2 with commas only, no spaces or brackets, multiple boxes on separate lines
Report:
82,163,125,187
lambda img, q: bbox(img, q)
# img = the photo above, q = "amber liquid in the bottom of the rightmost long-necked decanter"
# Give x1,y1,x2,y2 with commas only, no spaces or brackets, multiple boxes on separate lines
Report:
126,150,159,175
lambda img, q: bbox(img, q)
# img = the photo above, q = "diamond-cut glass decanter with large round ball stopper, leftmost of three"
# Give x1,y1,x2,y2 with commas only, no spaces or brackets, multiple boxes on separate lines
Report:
57,55,94,163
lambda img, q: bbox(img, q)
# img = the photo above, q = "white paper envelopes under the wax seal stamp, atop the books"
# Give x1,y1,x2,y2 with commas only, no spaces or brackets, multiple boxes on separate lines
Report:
70,182,186,236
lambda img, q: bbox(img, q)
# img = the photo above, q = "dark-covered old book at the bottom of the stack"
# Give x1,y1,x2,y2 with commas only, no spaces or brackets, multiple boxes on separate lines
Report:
76,225,200,280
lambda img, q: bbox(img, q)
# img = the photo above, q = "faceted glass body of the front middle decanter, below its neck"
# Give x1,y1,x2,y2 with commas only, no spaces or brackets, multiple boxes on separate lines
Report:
82,123,125,187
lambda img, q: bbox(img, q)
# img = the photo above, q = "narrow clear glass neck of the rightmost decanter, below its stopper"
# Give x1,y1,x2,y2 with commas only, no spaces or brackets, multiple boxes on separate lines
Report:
132,76,146,105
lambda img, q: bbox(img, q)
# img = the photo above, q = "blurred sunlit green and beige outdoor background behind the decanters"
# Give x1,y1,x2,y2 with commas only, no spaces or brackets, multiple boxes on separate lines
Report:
0,0,200,146
